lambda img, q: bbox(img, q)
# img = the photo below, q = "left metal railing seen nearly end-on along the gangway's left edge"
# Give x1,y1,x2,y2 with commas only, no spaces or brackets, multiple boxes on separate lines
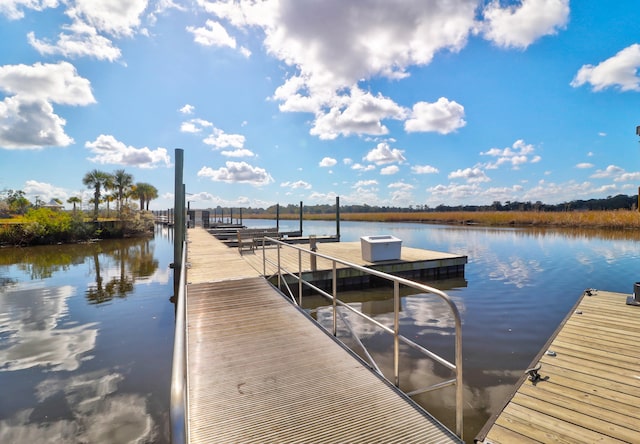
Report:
170,242,189,444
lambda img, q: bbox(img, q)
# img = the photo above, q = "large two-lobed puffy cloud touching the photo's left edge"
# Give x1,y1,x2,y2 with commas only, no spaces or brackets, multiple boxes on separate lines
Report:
0,62,95,149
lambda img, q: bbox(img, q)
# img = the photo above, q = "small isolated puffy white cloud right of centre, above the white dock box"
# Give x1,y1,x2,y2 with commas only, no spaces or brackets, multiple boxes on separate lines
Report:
404,97,467,134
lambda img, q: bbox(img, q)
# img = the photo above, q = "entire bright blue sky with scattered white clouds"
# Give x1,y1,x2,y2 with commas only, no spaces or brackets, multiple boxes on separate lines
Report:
0,0,640,209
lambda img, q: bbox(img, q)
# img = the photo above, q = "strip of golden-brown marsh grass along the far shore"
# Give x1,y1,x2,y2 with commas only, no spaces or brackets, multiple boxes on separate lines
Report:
244,210,640,229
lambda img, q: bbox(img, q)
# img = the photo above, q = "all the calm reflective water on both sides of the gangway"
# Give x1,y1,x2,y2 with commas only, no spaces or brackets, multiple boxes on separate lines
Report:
0,220,640,443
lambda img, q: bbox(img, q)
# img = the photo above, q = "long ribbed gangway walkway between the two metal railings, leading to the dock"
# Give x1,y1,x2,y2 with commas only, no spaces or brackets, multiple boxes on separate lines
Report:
186,228,462,443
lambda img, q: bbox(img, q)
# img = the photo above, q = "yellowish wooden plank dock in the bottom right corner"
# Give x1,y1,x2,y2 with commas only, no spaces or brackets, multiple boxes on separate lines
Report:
476,290,640,444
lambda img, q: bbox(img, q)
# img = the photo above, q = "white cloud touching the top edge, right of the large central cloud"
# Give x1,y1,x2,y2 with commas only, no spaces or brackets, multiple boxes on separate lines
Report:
480,0,569,49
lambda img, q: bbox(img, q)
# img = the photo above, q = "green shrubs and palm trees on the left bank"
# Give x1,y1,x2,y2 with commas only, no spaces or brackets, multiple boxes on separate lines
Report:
0,170,158,245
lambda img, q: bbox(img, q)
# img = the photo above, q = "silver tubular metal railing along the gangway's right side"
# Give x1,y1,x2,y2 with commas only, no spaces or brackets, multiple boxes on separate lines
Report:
262,237,464,438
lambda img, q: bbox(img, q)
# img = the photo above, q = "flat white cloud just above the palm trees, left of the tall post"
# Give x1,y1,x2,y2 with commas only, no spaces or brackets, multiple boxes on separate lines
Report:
84,134,171,168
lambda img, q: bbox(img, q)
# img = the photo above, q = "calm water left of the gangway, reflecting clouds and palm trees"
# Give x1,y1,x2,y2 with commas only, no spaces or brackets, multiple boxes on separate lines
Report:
0,227,174,443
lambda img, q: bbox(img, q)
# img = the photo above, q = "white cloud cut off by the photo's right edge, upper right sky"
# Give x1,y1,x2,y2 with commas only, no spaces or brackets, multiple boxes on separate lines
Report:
571,43,640,91
